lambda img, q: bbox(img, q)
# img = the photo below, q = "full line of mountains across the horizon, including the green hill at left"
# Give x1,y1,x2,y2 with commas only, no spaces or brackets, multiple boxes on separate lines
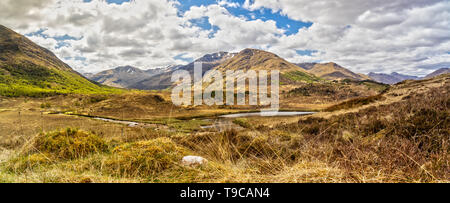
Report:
0,25,449,96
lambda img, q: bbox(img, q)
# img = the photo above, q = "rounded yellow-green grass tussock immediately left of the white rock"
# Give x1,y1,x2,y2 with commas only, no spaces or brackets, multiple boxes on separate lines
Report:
105,138,185,177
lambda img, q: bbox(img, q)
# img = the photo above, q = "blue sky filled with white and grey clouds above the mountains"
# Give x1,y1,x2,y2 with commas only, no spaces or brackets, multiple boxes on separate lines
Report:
0,0,450,76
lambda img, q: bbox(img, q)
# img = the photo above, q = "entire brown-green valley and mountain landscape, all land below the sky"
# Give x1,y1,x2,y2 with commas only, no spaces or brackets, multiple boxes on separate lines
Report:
0,26,450,183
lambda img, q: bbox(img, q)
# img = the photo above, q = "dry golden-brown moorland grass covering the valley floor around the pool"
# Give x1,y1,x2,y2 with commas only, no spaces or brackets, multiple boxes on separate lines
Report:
0,76,450,182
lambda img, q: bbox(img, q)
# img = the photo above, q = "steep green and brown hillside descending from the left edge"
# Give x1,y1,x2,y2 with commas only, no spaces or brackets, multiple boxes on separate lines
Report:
0,25,119,97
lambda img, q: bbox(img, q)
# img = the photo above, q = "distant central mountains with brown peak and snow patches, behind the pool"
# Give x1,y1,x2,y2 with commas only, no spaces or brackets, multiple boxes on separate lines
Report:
88,49,370,90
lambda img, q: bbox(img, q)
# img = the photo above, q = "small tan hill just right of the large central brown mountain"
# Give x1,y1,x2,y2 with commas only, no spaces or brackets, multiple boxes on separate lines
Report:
297,63,370,81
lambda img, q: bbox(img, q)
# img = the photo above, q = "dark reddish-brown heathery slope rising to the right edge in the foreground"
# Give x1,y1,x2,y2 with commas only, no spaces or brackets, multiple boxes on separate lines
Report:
277,79,450,182
